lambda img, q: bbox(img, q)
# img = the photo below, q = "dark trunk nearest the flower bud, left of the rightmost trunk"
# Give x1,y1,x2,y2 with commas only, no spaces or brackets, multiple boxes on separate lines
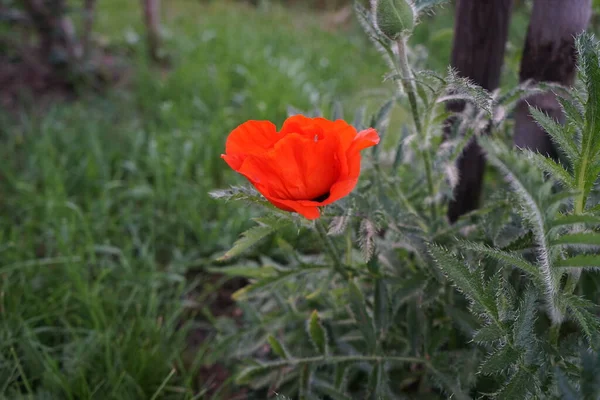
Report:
448,0,512,222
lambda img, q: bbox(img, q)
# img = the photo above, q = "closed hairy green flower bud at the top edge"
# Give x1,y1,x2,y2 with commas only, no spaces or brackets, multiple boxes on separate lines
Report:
372,0,416,40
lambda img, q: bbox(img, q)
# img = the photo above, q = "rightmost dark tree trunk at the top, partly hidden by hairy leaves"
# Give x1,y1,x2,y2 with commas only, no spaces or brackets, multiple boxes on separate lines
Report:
515,0,592,158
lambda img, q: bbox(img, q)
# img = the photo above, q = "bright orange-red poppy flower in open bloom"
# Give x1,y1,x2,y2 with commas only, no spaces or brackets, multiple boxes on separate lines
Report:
221,115,379,219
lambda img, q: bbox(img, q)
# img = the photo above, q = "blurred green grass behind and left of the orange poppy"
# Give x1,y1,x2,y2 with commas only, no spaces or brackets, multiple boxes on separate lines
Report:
0,0,389,399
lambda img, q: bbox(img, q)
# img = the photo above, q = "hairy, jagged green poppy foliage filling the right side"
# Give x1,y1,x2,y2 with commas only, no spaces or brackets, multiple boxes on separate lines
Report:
210,2,600,399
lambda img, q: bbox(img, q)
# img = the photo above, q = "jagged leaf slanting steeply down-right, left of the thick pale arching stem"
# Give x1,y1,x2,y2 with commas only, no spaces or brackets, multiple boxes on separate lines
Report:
429,245,498,318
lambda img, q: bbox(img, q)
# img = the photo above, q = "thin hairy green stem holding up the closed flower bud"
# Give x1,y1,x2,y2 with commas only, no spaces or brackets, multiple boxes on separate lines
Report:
396,36,436,219
